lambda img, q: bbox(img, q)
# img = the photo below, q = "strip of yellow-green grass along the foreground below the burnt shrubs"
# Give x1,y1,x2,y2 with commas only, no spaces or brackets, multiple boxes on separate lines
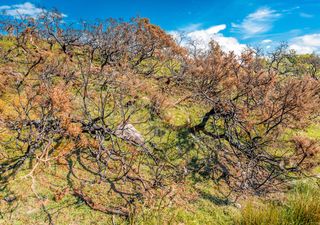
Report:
0,170,320,225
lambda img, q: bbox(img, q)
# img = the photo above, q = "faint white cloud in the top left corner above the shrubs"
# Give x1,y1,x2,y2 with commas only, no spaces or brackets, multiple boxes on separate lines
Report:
0,2,67,18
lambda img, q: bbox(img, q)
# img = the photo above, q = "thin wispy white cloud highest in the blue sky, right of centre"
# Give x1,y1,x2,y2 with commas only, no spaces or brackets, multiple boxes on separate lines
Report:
232,7,281,38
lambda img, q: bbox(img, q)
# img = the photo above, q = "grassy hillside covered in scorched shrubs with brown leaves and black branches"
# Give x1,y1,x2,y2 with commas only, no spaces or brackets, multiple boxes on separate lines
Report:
0,13,320,225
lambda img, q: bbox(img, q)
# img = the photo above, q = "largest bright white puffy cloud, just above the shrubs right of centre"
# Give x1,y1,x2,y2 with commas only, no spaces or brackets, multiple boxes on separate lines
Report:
169,24,246,54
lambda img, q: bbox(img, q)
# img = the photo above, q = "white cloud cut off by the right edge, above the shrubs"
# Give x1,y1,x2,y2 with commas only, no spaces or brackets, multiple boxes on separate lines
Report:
289,33,320,54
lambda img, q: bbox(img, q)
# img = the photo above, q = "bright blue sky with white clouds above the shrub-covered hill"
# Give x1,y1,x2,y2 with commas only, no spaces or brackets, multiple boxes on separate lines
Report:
0,0,320,53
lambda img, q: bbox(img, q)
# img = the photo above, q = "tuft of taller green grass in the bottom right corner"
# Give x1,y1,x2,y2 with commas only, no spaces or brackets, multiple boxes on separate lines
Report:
234,180,320,225
